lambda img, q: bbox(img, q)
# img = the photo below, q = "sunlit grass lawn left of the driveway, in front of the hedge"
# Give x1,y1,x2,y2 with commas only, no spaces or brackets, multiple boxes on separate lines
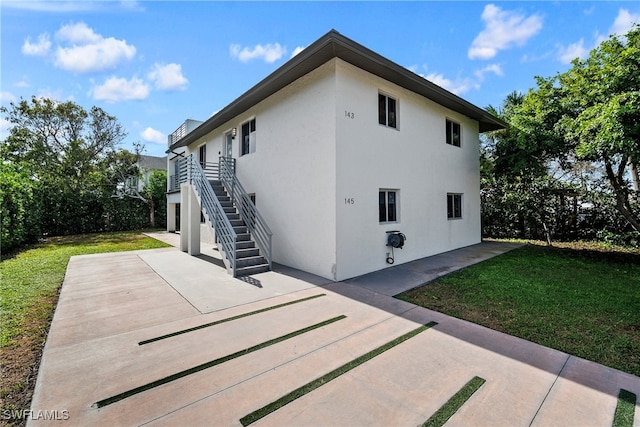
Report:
0,232,168,424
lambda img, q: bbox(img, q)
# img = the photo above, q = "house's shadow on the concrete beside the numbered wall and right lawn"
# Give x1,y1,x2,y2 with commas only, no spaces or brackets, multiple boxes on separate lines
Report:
273,241,640,406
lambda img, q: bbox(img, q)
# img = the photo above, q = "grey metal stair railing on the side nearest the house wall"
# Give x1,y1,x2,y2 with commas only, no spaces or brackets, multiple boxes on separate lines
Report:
219,156,273,269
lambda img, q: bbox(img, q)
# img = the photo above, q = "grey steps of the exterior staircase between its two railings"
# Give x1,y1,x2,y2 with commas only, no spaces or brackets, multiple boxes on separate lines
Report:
209,180,270,276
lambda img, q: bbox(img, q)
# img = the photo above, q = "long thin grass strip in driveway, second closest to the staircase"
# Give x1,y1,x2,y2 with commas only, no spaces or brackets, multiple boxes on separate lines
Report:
94,315,347,408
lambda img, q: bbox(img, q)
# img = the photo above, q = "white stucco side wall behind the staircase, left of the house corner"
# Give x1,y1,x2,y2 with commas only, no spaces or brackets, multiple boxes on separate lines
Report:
216,61,336,279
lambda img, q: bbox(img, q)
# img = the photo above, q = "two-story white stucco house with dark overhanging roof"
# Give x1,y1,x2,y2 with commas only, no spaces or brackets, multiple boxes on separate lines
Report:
167,31,505,281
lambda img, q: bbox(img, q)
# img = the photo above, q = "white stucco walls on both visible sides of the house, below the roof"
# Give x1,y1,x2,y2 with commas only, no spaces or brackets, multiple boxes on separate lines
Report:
172,59,481,281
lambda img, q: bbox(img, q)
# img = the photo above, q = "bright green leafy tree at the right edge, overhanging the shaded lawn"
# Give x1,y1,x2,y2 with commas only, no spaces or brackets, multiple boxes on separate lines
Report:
523,26,640,232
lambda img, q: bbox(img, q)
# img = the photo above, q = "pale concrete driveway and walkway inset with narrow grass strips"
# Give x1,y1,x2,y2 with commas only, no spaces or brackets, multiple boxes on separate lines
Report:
28,234,640,426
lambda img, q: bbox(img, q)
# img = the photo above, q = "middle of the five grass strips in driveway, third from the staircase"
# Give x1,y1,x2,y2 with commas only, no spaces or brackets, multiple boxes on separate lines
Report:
240,322,438,427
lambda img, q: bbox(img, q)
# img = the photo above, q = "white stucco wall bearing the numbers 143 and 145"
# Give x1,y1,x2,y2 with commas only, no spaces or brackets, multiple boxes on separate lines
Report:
335,60,481,280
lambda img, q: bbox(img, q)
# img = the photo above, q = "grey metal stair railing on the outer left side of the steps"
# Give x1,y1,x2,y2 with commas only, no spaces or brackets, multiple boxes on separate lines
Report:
188,154,238,277
